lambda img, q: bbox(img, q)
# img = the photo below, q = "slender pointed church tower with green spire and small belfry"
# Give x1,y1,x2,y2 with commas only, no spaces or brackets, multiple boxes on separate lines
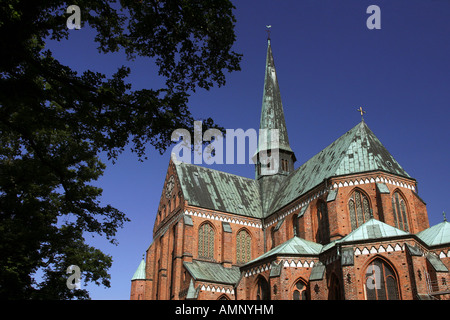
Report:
255,38,296,180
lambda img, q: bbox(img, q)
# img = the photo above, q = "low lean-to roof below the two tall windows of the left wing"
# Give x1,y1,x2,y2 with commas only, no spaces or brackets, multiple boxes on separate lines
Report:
183,260,241,284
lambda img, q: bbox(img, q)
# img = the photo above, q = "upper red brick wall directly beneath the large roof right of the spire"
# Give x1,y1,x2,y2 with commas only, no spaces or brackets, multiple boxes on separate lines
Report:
266,172,429,248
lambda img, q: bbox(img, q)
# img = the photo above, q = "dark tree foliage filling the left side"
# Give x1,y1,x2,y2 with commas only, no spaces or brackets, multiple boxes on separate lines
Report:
0,0,240,299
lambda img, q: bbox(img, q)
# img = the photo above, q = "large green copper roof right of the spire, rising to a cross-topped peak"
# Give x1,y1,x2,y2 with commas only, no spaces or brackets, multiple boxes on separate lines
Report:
268,121,410,214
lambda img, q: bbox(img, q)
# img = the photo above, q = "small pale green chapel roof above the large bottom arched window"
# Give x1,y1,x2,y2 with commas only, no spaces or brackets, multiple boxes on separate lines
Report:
339,218,409,242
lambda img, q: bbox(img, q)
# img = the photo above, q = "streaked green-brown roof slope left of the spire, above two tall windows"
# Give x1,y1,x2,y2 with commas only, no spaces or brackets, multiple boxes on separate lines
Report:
174,161,262,218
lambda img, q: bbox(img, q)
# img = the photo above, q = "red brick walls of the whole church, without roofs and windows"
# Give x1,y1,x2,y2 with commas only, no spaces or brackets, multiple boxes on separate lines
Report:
130,162,450,299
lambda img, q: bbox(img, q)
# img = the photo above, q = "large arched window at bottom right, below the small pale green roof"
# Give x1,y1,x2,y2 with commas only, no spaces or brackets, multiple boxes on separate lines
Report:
364,259,399,300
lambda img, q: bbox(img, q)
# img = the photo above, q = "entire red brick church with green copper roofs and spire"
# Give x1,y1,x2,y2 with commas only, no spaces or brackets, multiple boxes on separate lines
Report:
131,40,450,300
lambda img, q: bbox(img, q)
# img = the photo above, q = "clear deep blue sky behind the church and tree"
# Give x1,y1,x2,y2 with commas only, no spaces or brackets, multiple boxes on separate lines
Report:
48,0,450,299
